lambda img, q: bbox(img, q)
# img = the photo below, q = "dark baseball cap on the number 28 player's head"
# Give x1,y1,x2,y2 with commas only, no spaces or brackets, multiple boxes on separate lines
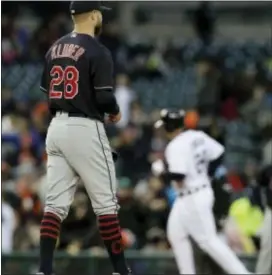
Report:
70,1,111,15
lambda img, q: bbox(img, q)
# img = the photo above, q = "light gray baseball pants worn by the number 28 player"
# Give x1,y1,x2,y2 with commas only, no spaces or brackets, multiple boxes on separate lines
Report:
45,113,119,220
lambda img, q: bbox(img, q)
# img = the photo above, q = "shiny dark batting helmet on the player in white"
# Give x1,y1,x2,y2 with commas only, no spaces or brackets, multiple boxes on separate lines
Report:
154,109,185,132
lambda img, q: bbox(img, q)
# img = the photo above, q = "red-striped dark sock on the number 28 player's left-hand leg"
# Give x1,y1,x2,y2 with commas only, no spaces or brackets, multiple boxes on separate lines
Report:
39,212,61,275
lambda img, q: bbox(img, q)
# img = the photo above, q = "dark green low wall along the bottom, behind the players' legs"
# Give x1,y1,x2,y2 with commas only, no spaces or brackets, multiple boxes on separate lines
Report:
2,251,256,275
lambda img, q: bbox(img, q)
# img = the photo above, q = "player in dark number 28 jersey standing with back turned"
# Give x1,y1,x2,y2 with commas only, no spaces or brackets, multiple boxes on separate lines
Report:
39,1,131,275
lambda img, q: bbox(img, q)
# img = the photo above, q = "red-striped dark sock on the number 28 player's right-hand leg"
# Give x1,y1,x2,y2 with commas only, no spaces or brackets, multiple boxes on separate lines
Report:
98,214,131,275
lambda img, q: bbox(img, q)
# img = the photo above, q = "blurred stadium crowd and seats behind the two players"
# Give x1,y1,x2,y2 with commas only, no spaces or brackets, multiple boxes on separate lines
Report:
1,1,272,275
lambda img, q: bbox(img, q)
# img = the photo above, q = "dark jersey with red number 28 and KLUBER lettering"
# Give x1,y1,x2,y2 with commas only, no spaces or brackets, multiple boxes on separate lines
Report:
41,33,113,121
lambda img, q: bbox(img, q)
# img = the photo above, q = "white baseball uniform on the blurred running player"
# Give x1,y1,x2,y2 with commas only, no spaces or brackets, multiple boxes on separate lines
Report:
165,130,250,274
